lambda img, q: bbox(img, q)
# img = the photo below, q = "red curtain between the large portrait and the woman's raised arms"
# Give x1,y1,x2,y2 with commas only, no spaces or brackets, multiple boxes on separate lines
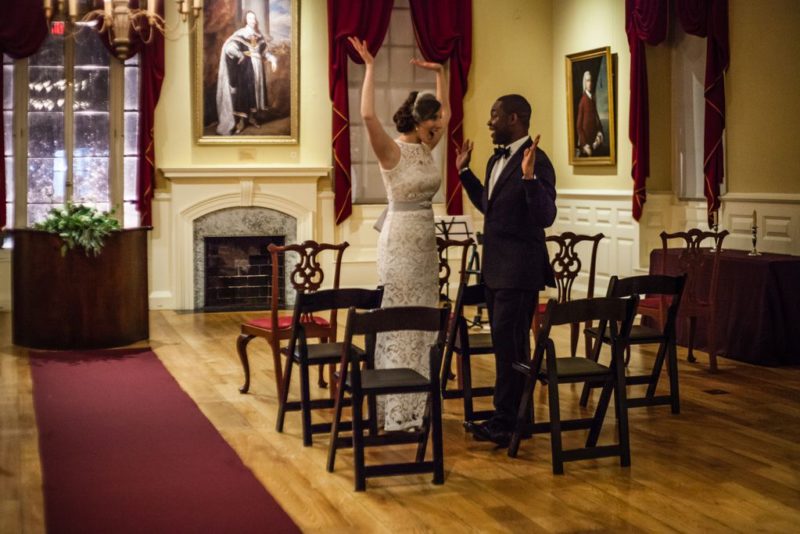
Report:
328,0,393,224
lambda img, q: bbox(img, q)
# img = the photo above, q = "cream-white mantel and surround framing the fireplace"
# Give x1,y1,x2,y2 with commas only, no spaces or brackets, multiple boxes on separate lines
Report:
161,166,333,310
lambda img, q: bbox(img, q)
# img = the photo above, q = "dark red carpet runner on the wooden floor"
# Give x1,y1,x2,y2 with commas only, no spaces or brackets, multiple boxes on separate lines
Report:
30,349,299,534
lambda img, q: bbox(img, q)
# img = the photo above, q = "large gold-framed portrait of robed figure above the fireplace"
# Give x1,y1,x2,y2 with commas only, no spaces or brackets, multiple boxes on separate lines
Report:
192,0,300,144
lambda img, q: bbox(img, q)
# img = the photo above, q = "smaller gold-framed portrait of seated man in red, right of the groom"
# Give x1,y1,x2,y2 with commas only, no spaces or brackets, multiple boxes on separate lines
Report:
566,47,616,165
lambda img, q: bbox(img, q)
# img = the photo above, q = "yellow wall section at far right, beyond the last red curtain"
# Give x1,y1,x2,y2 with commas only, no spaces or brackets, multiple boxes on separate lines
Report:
725,0,800,193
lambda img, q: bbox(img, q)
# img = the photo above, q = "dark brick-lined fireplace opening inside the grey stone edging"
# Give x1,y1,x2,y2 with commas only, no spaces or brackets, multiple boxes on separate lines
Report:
203,236,286,311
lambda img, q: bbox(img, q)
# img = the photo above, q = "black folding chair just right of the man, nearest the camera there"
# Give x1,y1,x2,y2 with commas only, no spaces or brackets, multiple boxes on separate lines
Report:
508,296,639,475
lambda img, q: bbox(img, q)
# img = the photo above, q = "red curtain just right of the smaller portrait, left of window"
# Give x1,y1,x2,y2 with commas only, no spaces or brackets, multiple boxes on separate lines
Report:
625,0,669,221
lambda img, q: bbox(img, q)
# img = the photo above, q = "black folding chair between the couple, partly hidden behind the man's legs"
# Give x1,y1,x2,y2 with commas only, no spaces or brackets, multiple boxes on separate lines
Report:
442,282,494,423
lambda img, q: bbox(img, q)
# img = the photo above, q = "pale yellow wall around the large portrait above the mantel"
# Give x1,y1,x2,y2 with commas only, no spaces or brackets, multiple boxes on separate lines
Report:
155,0,331,178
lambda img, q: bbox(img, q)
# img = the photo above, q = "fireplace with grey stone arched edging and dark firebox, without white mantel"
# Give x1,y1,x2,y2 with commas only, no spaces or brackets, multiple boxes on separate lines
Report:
193,207,297,311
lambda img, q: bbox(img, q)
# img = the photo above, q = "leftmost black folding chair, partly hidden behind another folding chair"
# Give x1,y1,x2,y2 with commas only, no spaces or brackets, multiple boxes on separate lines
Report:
275,288,383,447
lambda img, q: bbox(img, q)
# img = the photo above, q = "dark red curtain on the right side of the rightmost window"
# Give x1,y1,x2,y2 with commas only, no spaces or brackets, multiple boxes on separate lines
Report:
675,0,730,225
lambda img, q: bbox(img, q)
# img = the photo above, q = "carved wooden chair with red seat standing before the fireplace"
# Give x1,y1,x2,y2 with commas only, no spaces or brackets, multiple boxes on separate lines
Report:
236,240,349,398
